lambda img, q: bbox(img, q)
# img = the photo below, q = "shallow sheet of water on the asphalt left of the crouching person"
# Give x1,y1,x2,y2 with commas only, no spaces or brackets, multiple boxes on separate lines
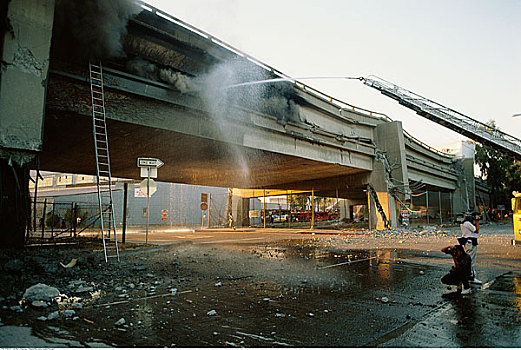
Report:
0,240,450,347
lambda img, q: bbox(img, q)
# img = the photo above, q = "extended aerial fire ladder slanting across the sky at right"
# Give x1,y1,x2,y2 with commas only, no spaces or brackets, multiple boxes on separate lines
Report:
363,76,521,160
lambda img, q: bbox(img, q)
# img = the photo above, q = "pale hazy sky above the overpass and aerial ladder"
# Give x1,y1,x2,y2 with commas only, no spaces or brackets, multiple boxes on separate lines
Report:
142,0,521,148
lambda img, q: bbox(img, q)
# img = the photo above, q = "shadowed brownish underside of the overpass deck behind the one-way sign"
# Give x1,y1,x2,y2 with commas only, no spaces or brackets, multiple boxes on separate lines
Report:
40,109,367,190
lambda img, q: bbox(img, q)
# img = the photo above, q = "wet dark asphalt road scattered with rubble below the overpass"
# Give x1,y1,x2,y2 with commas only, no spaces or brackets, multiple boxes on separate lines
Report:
0,230,521,347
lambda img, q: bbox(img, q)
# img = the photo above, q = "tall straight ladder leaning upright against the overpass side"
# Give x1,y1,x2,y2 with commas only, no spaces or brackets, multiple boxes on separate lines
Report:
89,62,119,262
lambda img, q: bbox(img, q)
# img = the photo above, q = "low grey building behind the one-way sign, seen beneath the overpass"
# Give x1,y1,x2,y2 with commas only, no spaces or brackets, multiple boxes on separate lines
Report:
29,172,228,227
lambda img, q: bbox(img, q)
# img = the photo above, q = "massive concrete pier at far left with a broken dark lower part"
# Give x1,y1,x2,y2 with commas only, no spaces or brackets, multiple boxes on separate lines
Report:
0,0,54,247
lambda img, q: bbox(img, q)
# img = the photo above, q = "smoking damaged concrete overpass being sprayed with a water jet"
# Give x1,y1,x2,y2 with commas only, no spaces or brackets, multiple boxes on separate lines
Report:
0,0,480,246
